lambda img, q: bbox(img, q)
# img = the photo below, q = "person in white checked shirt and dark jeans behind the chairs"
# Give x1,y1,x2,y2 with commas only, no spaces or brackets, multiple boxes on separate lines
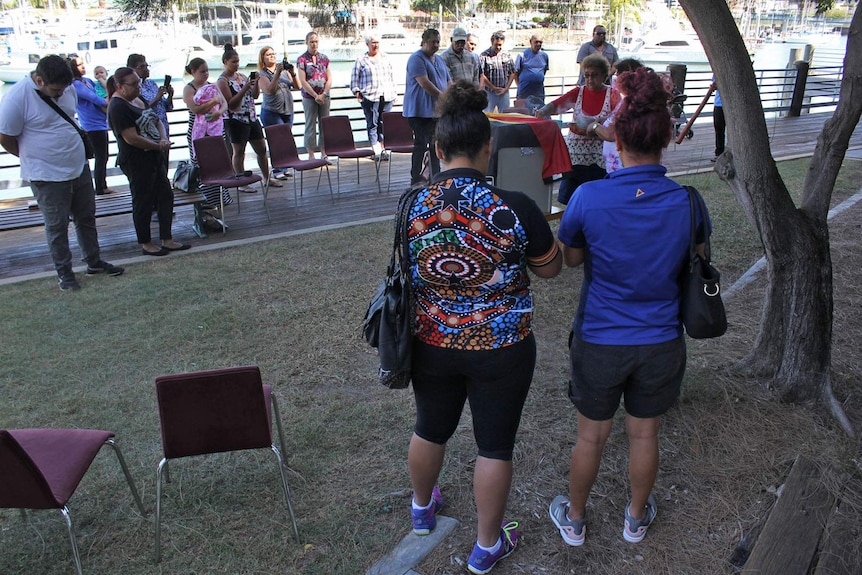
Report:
350,34,397,160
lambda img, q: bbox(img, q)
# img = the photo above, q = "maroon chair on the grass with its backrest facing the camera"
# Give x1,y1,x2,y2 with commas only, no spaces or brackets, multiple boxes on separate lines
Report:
156,366,299,562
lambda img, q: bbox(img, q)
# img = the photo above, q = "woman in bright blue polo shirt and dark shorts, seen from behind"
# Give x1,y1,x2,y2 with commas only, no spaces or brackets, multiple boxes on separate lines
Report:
549,68,709,546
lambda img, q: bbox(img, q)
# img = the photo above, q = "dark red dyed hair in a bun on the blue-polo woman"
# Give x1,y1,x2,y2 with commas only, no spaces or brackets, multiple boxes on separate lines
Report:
614,68,671,154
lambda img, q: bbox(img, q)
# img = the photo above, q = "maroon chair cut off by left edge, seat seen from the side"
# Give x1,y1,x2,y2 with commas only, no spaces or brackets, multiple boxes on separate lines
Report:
0,429,146,575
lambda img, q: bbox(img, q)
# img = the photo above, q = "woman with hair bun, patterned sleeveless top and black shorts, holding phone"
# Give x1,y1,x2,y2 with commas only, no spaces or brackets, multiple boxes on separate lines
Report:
216,44,269,189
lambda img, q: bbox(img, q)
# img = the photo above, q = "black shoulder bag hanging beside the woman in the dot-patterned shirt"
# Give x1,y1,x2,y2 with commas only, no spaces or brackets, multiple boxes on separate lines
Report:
362,187,422,389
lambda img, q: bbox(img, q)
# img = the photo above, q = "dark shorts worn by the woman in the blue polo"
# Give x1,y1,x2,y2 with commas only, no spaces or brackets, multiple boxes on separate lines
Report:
569,336,685,421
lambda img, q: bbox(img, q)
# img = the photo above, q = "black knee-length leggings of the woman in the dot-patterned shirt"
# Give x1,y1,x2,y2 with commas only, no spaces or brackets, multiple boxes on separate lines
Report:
412,334,536,461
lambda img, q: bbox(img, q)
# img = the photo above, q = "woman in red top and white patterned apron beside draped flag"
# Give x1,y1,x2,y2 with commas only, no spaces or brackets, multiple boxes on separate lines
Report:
535,53,620,204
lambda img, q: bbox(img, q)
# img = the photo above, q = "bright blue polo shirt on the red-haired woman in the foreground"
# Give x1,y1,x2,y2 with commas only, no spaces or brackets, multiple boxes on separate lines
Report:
557,165,709,345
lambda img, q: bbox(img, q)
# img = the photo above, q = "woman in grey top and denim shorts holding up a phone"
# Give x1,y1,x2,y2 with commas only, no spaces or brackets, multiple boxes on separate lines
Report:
257,46,299,182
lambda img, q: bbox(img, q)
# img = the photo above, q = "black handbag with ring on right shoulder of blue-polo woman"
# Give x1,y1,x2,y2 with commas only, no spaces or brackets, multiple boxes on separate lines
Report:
680,186,727,339
